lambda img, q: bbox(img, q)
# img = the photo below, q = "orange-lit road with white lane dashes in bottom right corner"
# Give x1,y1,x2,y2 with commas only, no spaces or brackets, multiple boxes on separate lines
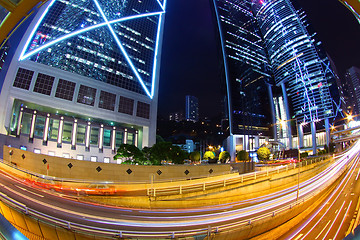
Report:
280,147,360,240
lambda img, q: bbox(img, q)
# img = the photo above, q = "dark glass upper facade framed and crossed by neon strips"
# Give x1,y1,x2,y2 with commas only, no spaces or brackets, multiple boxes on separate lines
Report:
19,0,166,98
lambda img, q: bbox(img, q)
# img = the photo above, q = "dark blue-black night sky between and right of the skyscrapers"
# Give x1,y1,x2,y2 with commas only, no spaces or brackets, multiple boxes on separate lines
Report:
158,0,360,117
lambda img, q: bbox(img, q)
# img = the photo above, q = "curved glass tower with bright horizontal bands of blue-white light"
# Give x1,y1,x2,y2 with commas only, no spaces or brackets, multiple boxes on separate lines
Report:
253,0,334,151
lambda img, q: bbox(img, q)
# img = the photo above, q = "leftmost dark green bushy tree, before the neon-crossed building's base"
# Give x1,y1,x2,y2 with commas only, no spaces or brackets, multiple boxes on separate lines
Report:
114,144,144,164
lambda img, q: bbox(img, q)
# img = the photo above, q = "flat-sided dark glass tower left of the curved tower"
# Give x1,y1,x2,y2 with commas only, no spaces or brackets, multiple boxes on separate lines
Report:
213,0,273,158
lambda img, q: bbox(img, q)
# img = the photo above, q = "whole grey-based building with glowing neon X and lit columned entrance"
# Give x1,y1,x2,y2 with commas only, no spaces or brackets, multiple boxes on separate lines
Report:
0,0,166,162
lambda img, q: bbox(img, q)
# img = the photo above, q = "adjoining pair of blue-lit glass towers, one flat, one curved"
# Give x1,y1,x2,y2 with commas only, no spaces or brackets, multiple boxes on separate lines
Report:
214,0,335,158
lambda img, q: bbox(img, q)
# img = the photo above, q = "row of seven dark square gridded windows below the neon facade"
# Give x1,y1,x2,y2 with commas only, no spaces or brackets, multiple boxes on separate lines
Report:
13,68,150,119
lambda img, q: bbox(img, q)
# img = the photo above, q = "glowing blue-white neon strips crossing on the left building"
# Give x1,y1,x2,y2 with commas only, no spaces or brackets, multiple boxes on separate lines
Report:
19,0,166,99
